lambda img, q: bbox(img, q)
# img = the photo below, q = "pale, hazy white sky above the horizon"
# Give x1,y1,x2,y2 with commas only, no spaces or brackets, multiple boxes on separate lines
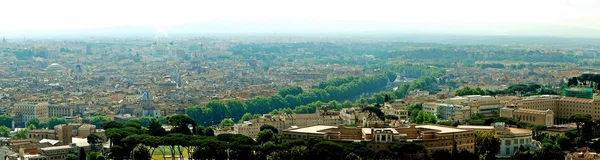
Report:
0,0,600,36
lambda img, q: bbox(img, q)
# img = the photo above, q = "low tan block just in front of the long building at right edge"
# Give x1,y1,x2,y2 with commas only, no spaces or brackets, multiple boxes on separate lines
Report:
500,107,554,127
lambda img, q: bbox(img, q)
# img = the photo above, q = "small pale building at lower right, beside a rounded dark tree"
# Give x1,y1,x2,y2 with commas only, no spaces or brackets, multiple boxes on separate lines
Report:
494,122,536,157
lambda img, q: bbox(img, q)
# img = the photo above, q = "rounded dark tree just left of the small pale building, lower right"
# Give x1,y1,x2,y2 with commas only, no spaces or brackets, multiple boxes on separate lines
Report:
475,132,500,158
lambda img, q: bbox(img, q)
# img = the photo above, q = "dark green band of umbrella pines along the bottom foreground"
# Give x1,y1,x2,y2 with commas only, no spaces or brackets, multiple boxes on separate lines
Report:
102,115,477,160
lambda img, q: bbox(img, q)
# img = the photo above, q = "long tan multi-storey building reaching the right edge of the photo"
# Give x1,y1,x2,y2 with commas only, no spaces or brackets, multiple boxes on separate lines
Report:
512,95,600,124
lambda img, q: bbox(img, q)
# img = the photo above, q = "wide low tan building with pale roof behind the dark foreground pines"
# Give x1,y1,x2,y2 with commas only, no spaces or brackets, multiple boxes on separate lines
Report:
281,125,475,154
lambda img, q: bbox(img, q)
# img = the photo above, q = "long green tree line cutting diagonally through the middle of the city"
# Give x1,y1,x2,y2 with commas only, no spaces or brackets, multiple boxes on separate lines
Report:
186,73,395,125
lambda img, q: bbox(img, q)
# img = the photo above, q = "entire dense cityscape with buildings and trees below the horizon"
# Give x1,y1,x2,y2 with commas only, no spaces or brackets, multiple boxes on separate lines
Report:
0,36,600,160
